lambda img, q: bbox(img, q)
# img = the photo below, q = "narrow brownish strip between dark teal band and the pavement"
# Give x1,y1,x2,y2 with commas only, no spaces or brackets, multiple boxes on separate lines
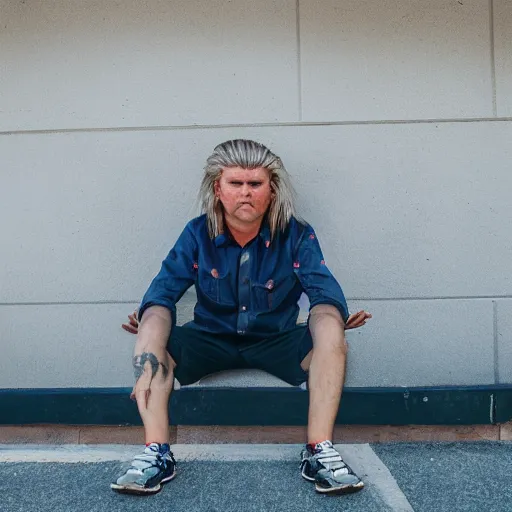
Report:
0,423,512,445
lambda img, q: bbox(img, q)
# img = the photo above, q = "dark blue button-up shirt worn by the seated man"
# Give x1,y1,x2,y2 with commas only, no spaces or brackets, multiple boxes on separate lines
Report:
139,215,348,336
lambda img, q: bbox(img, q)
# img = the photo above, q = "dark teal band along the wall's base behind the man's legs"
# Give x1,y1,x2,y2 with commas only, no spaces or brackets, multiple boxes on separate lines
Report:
0,385,512,427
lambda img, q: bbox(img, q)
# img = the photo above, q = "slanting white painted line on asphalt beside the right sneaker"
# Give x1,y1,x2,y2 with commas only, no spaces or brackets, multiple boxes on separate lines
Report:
336,444,414,512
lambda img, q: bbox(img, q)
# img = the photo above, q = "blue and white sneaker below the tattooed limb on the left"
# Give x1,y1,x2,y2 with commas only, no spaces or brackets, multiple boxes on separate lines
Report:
110,443,176,494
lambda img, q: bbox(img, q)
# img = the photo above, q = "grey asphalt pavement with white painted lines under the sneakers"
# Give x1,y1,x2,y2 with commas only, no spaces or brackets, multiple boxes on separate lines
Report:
0,442,512,512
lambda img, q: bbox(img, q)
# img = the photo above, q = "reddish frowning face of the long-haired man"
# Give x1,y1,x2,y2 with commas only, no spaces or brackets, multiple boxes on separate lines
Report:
215,167,272,224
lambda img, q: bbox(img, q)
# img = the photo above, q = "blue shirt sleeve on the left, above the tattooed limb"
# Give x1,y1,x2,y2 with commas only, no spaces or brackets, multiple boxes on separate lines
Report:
138,224,197,326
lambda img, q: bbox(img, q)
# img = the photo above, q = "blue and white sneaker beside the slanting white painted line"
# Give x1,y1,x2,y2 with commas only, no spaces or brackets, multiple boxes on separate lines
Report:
300,441,364,494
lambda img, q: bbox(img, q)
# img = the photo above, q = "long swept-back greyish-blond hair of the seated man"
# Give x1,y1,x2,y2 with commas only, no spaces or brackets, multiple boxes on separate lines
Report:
199,139,296,238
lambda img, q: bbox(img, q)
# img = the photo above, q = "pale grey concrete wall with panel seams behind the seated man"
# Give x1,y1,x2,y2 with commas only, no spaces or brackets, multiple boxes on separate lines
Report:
0,0,512,387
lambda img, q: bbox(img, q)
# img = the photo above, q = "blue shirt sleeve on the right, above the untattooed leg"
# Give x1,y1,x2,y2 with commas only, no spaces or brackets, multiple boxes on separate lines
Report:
294,226,349,322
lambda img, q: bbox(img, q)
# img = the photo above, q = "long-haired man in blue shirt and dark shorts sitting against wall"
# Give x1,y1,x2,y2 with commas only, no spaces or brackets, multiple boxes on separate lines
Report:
111,140,371,494
